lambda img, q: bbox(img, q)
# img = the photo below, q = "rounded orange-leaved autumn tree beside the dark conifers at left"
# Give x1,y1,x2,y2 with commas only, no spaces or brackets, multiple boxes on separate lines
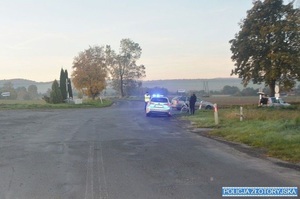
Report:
72,46,107,99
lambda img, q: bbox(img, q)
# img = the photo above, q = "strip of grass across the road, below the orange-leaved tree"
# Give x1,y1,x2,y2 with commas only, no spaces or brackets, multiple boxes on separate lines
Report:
0,99,113,110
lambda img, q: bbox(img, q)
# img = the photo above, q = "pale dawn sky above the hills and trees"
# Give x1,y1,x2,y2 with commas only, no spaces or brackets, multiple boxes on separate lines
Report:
0,0,290,82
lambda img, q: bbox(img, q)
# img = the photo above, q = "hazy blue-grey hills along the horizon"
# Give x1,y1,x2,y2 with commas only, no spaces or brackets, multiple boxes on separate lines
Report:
0,78,263,94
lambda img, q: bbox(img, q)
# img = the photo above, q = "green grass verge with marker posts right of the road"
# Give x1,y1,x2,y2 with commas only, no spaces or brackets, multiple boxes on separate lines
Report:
183,105,300,163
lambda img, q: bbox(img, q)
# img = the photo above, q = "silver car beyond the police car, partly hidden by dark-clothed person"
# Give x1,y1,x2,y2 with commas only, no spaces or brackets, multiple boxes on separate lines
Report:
171,96,214,110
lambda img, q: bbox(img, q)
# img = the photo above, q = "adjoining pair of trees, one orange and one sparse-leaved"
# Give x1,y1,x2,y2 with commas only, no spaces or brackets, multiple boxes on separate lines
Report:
72,39,145,99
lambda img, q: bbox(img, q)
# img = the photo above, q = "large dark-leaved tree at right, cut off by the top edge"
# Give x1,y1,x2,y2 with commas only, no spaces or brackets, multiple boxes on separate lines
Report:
230,0,300,96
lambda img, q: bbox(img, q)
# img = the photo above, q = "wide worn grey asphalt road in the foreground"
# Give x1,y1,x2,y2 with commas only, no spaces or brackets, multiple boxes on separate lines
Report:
0,101,300,199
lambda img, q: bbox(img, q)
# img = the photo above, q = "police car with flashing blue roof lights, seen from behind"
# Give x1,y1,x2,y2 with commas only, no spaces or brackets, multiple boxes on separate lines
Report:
146,96,172,116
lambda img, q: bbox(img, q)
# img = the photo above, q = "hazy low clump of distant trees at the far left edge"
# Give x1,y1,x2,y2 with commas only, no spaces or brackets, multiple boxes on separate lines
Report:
0,82,39,100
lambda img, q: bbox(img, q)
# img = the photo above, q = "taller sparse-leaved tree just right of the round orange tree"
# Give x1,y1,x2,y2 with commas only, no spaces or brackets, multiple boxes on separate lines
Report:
106,39,145,97
